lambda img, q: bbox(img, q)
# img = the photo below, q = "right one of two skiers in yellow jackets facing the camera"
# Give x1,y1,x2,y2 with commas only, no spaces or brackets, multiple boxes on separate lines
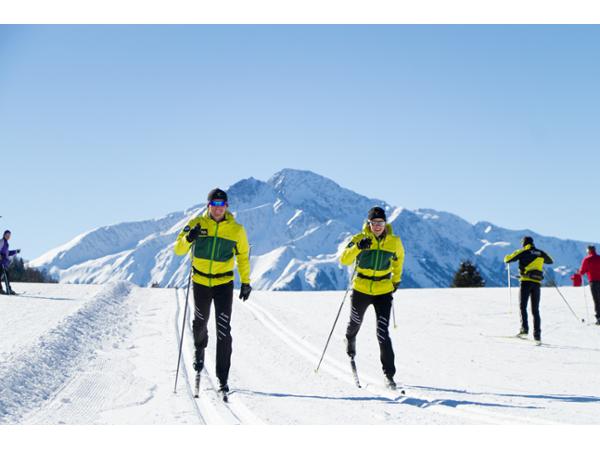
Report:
340,207,404,389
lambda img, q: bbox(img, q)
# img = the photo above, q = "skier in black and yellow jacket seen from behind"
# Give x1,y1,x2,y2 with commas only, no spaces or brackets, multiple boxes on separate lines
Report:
504,236,554,343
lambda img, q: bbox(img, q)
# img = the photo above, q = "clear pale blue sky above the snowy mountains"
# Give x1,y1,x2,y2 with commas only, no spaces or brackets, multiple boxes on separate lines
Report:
0,25,600,259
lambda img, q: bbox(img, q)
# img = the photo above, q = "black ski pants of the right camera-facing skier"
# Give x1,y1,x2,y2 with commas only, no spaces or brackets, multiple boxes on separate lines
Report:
346,290,396,376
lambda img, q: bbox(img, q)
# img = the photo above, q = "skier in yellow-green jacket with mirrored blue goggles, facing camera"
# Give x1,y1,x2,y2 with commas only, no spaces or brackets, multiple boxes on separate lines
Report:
175,188,252,399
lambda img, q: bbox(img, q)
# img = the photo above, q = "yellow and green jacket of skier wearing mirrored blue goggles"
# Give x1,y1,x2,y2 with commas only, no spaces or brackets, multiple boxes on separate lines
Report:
174,211,250,286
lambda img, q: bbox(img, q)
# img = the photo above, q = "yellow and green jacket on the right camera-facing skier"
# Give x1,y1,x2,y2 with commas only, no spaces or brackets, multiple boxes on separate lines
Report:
340,224,404,295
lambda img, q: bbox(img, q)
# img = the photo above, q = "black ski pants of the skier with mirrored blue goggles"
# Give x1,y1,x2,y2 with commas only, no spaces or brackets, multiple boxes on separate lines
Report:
192,281,233,384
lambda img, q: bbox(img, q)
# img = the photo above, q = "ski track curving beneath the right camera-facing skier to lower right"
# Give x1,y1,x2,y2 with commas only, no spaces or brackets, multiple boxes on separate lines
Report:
246,303,558,425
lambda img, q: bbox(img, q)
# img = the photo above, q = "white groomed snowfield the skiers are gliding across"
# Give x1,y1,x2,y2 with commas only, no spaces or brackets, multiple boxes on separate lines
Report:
0,281,600,425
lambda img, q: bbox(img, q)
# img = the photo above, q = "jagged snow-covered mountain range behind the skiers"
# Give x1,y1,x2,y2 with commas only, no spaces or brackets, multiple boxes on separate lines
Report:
30,169,588,290
